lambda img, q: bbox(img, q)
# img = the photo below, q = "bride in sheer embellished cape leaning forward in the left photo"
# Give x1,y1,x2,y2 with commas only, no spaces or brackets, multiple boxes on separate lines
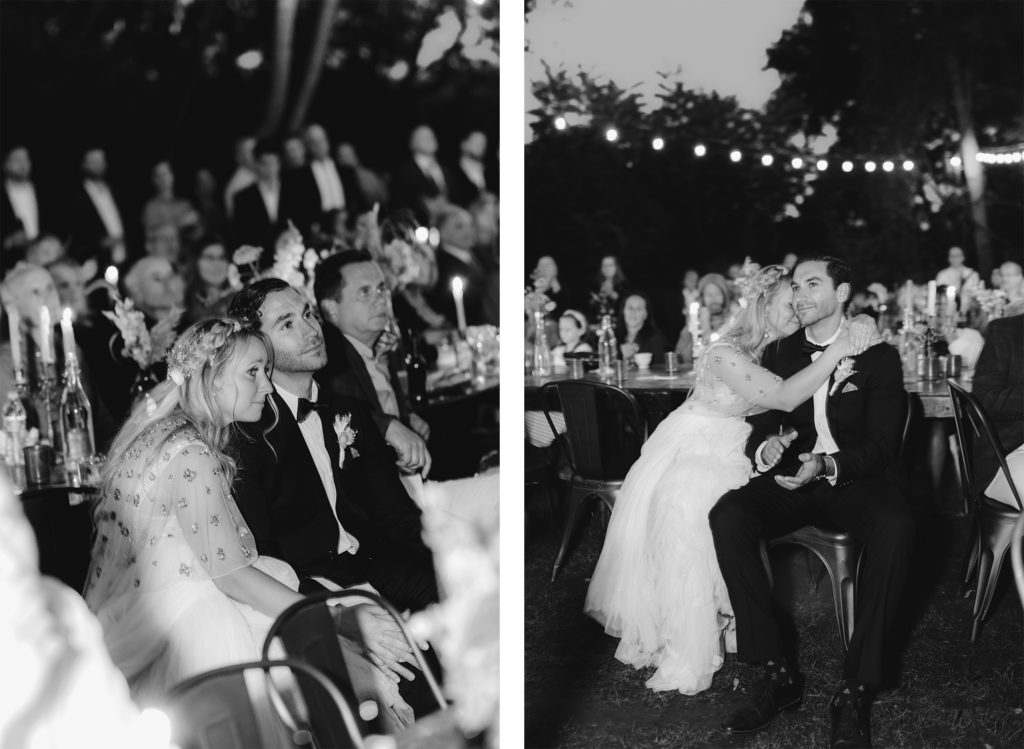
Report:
85,318,413,729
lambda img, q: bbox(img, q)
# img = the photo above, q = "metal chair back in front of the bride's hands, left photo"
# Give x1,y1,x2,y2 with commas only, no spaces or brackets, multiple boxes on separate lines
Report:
263,589,447,735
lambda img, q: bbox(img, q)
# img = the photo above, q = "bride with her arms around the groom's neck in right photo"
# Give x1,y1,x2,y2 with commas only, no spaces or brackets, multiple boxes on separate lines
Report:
585,265,878,695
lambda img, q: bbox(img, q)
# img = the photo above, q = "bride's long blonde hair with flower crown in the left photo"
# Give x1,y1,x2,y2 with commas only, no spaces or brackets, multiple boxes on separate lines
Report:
102,318,278,495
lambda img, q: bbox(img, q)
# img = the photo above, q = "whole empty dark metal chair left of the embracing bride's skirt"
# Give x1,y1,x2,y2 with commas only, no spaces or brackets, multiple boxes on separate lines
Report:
541,380,647,582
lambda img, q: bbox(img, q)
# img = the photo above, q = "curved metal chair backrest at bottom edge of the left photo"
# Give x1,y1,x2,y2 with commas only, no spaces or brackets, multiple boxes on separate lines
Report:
167,659,362,749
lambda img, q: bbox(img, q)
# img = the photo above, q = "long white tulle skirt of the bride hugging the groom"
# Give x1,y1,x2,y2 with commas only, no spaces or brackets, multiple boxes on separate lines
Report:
585,405,751,695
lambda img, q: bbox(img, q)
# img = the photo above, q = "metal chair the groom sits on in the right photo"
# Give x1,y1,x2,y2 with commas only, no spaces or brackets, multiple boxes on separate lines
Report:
761,393,913,651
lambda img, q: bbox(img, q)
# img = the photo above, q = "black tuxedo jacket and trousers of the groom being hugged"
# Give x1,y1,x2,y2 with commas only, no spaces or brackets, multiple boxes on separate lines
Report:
710,330,914,685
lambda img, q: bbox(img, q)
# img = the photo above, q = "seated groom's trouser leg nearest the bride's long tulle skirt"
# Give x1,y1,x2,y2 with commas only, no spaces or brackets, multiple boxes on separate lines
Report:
708,476,816,663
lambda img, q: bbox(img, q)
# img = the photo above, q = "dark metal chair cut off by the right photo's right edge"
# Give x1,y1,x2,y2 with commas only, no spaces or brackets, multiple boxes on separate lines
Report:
946,379,1024,642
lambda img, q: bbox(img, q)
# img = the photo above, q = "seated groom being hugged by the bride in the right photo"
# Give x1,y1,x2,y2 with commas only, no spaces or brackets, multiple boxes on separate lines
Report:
709,257,914,747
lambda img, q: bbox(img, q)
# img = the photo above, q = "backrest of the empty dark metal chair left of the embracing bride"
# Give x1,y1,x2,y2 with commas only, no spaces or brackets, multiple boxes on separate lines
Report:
541,380,647,482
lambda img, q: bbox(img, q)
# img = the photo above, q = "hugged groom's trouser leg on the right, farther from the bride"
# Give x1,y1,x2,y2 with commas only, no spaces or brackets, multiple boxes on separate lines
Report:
820,477,914,686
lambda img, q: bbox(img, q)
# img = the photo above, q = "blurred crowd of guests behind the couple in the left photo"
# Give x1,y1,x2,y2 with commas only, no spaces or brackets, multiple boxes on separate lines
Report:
0,124,499,445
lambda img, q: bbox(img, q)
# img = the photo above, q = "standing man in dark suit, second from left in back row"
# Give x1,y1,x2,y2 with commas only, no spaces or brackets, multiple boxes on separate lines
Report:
68,148,128,267
